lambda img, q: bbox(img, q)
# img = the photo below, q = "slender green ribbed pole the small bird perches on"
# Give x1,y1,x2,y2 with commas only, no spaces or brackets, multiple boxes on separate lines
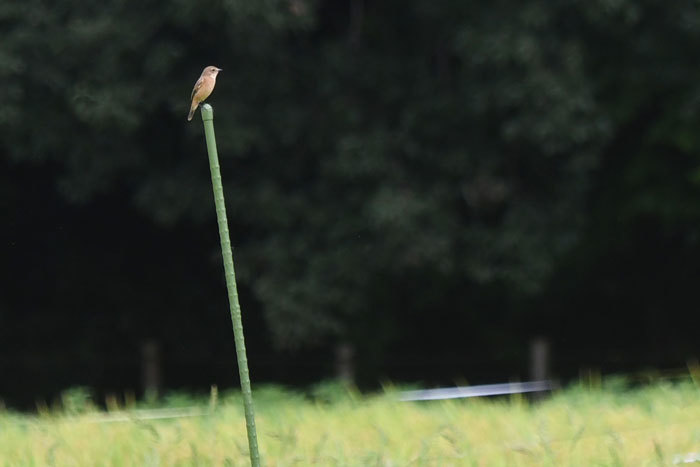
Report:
201,104,260,467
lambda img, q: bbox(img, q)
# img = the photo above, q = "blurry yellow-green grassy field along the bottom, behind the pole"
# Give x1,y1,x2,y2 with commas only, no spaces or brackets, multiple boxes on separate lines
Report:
0,381,700,467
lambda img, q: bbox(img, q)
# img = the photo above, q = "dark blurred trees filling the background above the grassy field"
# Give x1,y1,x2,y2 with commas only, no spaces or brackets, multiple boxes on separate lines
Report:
0,0,700,408
